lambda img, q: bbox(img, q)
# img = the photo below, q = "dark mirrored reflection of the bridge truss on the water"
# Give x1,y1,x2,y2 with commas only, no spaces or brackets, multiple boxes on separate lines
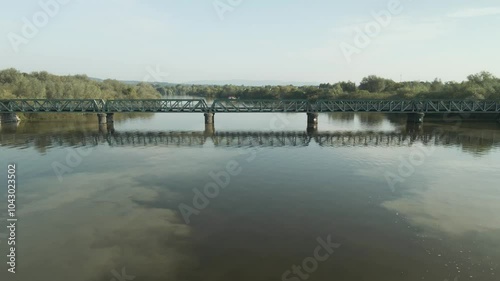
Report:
0,132,500,148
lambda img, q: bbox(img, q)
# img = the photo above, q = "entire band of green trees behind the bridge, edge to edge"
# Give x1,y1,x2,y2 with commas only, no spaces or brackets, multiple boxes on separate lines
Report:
0,69,500,100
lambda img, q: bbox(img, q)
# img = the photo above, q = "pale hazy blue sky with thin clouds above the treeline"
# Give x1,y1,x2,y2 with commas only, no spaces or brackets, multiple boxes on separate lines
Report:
0,0,500,82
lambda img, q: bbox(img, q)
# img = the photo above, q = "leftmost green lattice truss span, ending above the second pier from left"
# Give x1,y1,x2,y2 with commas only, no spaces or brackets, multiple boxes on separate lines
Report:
0,99,105,113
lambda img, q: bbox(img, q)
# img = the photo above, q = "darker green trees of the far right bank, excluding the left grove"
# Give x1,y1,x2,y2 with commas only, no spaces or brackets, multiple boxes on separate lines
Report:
156,72,500,100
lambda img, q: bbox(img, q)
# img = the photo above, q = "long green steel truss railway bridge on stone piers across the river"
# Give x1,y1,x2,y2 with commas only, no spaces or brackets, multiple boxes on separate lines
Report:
0,99,500,124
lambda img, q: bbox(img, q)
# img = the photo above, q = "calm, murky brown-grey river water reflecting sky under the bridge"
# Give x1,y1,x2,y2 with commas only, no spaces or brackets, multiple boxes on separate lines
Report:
0,114,500,281
